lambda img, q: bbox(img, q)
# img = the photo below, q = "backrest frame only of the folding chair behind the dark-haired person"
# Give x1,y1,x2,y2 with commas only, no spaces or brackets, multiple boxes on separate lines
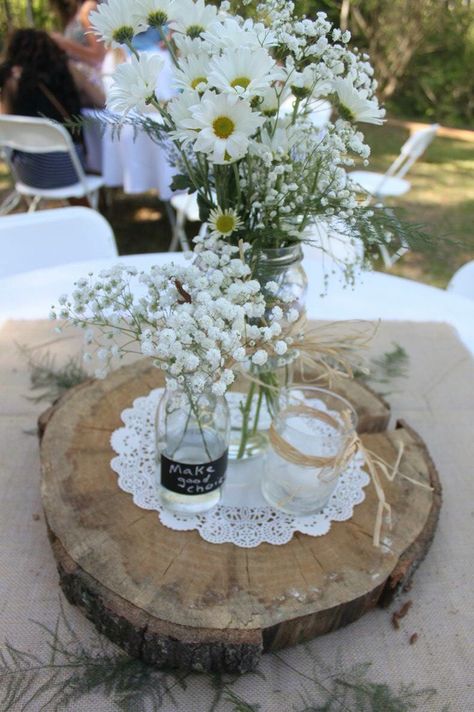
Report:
0,115,89,195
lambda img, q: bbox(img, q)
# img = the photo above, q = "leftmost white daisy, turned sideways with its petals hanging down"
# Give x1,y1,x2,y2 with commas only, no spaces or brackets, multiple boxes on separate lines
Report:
107,53,165,113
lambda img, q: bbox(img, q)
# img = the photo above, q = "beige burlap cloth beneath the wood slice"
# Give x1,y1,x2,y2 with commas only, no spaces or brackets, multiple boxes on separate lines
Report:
0,321,474,712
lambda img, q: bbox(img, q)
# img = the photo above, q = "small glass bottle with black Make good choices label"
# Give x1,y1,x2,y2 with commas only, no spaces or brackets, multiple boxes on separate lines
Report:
156,386,230,515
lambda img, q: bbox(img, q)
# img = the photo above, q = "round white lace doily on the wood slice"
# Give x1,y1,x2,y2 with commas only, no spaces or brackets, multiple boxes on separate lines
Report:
111,389,369,548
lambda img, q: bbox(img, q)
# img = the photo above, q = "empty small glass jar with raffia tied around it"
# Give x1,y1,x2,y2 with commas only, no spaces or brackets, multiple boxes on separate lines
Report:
262,386,357,516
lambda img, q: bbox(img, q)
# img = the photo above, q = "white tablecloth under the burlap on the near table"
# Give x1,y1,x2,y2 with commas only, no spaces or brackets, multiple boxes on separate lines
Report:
0,252,474,353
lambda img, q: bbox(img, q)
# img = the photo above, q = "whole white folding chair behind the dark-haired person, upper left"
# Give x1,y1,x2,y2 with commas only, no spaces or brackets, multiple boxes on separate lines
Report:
0,116,104,215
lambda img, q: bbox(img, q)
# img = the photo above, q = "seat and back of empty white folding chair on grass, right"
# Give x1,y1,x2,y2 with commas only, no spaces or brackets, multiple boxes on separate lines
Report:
349,124,439,201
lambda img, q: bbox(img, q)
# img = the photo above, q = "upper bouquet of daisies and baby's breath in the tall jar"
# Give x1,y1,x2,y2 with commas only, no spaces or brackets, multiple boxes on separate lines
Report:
91,0,387,260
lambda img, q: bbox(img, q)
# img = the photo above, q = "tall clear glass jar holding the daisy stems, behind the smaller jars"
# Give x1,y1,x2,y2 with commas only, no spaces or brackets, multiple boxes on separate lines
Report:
227,244,308,460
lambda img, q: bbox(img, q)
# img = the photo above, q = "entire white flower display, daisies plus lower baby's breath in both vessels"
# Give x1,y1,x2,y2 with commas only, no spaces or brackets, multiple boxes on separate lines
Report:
53,0,412,478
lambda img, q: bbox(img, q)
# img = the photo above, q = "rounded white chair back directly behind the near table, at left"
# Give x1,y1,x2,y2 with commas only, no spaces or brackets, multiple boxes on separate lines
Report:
0,207,118,278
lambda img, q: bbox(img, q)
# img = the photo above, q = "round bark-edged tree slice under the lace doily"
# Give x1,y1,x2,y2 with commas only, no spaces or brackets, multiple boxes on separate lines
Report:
40,362,440,672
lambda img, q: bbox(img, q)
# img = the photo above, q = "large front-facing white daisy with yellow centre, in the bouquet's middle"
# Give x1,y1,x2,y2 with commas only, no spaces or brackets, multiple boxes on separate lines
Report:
183,91,264,164
